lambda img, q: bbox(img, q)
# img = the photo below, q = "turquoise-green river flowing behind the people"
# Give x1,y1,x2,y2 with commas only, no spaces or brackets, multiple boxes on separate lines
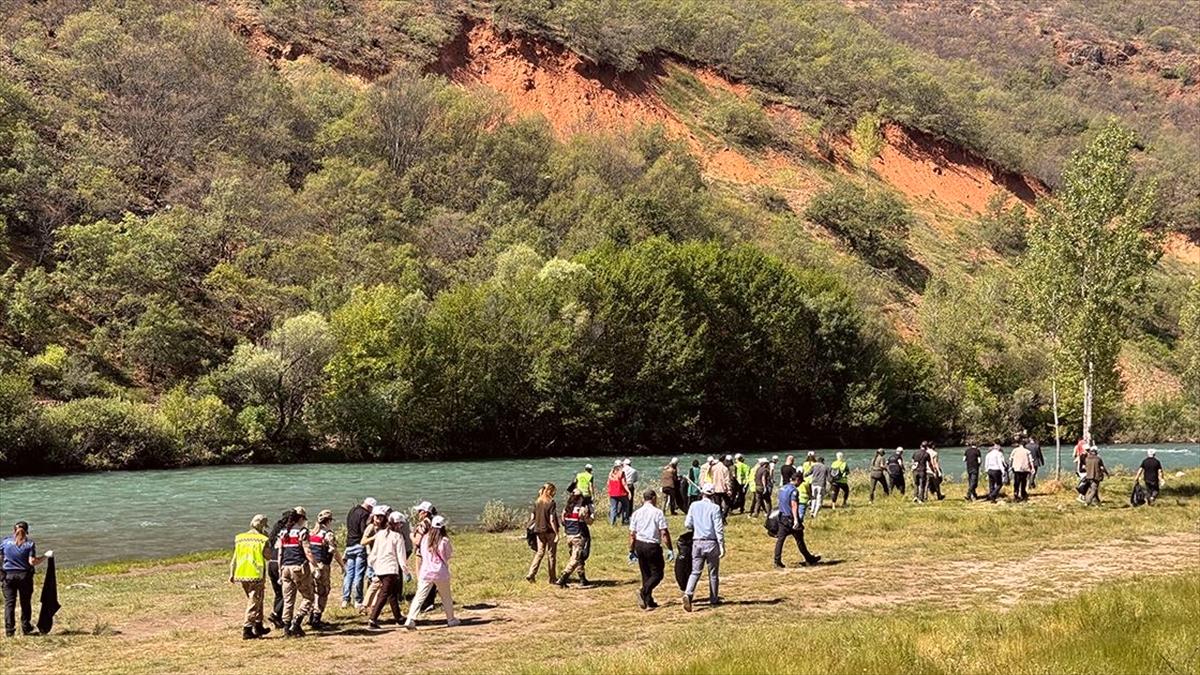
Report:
0,443,1200,566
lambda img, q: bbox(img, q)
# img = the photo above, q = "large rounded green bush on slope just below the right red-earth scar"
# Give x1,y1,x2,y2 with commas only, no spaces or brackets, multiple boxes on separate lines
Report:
804,180,913,267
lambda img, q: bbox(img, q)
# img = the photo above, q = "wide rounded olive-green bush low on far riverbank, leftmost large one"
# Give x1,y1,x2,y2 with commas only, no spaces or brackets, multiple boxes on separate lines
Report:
43,398,179,470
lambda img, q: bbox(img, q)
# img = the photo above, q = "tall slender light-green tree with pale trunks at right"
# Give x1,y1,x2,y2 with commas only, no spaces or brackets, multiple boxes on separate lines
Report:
1021,121,1162,464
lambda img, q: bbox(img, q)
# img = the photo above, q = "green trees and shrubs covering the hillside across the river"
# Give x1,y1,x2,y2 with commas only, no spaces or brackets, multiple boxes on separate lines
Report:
0,0,1200,472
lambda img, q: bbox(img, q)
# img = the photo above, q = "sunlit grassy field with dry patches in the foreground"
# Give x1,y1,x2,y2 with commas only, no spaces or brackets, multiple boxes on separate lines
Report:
0,470,1200,673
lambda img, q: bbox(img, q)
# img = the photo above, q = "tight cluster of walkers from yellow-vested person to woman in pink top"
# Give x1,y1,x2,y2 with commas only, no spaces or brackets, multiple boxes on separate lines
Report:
229,497,458,640
